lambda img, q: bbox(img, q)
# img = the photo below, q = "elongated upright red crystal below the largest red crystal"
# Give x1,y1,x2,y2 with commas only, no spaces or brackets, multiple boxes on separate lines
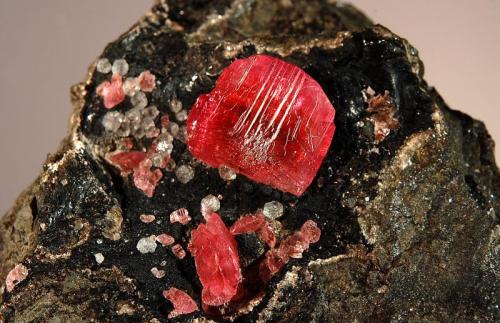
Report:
188,213,242,306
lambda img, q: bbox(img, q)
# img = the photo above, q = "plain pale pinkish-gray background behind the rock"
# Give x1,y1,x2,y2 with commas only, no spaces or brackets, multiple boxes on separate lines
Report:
0,0,500,216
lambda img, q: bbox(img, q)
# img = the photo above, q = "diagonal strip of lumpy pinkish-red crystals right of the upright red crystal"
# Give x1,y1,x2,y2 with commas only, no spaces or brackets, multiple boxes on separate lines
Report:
259,220,321,281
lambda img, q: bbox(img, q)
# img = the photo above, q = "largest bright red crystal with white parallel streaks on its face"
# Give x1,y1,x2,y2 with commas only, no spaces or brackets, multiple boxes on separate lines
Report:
187,55,335,195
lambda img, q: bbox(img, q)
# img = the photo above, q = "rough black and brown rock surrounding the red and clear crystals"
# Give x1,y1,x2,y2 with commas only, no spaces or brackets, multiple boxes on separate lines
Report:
0,0,500,322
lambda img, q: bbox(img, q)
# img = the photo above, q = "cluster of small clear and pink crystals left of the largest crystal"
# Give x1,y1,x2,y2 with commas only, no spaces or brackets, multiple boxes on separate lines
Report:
96,58,194,197
